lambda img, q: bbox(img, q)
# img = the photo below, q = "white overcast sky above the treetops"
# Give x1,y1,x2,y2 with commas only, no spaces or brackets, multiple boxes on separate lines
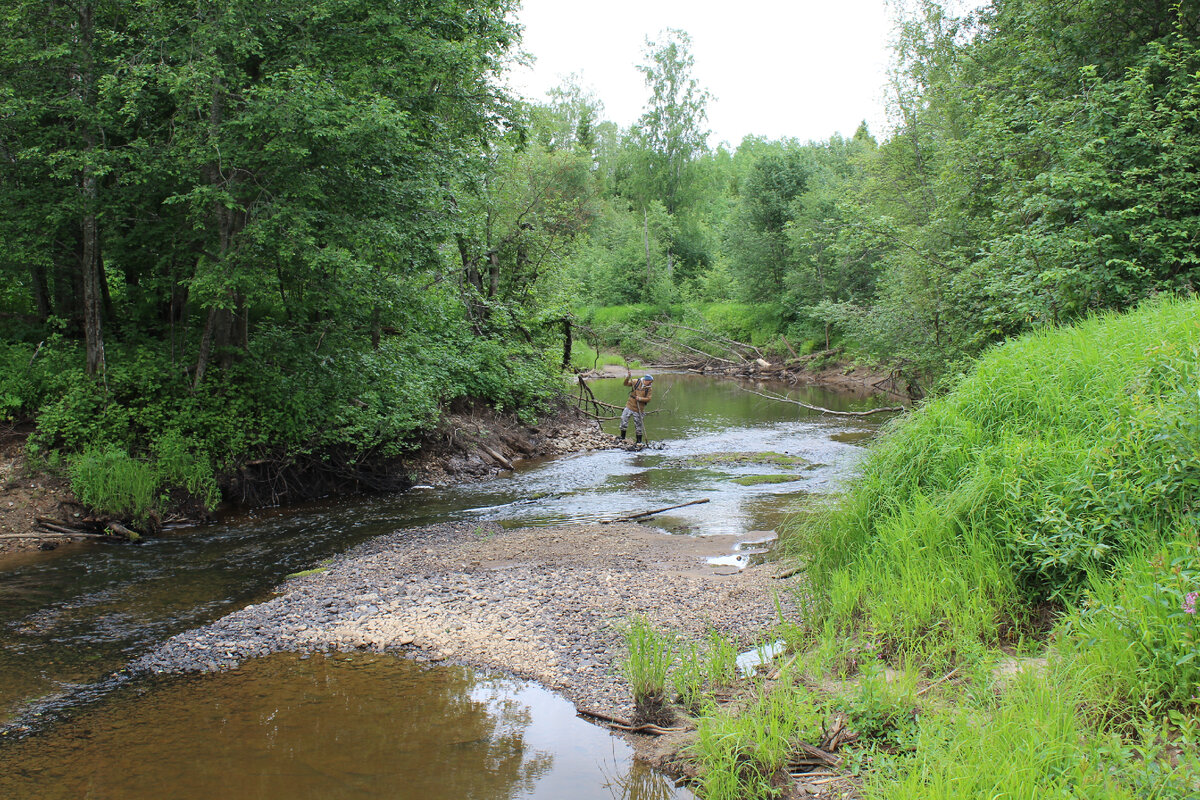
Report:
509,0,892,146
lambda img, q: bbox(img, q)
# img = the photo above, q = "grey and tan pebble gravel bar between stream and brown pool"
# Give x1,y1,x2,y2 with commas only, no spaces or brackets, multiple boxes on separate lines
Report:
131,524,791,716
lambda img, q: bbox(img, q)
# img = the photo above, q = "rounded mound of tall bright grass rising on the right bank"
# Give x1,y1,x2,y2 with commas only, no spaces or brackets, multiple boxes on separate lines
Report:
792,300,1200,661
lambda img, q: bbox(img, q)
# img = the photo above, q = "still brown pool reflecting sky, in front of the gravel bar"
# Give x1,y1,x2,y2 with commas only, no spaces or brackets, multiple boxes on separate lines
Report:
0,654,692,800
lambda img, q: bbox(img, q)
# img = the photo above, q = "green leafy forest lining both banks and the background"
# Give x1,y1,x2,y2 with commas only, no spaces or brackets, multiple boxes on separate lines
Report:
0,0,1200,515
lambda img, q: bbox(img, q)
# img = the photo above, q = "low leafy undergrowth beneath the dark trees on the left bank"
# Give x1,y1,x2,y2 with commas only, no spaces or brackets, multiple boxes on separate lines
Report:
0,330,557,522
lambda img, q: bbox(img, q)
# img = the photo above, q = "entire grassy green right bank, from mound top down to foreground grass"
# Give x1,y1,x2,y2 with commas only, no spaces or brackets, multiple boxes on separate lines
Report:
676,299,1200,800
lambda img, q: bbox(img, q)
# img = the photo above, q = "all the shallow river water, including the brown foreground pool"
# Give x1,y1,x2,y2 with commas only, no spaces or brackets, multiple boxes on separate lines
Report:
0,374,878,800
